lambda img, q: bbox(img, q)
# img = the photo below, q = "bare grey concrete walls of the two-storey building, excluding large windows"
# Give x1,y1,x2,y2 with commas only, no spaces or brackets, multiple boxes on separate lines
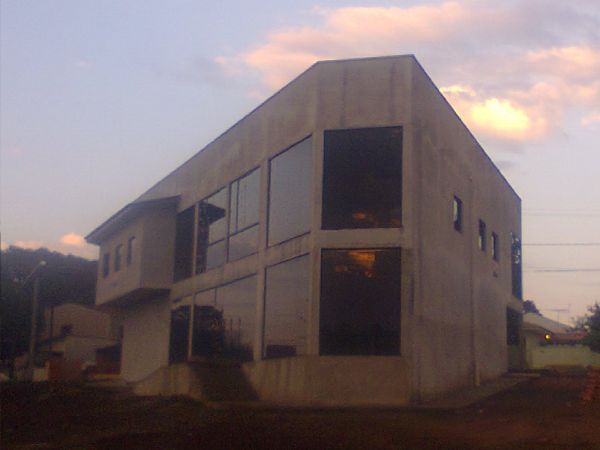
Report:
88,55,521,405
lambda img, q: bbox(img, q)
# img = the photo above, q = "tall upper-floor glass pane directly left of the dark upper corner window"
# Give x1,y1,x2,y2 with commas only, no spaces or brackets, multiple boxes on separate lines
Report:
268,138,312,245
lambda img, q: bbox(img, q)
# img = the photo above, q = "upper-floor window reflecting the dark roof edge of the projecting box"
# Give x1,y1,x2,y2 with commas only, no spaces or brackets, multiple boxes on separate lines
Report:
196,188,227,273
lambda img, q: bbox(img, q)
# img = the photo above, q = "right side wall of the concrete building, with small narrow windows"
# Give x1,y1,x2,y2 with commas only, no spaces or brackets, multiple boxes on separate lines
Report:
412,60,521,397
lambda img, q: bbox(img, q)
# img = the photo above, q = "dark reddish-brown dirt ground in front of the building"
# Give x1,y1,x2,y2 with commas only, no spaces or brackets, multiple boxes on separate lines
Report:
0,376,600,450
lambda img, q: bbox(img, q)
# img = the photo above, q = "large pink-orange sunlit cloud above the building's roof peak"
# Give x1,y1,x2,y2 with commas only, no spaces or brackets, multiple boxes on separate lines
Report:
215,0,600,141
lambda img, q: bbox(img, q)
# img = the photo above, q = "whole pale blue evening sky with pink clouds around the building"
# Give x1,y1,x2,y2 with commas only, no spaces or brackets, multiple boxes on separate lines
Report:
0,0,600,321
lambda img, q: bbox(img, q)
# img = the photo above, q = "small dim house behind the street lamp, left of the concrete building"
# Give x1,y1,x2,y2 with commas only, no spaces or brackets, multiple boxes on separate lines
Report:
34,303,120,381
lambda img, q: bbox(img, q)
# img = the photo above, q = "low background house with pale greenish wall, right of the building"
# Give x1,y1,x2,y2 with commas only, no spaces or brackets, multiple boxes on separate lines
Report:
523,313,600,370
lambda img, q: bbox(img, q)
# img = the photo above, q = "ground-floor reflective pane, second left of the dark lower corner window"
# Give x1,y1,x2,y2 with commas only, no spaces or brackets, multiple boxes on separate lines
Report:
216,276,256,361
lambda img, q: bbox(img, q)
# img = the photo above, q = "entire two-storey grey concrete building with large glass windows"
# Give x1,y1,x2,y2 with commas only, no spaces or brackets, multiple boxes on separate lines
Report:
87,55,522,405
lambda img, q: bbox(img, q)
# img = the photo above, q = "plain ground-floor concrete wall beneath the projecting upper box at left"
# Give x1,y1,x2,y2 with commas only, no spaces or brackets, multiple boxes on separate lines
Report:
121,297,171,382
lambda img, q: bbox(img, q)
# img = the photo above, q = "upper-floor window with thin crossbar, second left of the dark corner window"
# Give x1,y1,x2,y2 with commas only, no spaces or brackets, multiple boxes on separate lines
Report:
229,169,260,261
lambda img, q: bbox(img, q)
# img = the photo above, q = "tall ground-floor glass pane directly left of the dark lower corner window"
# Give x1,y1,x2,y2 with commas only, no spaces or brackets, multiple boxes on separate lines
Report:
264,256,309,358
